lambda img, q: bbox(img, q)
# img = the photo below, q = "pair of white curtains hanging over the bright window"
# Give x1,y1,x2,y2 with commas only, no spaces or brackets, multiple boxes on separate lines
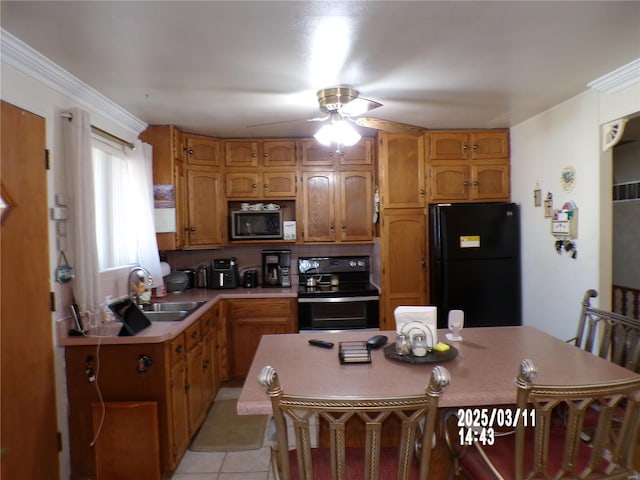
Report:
63,109,162,311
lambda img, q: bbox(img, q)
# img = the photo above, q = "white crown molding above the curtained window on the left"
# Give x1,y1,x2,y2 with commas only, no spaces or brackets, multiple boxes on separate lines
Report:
0,29,147,137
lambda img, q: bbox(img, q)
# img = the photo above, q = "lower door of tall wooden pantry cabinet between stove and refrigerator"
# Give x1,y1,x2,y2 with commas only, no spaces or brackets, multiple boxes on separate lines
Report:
380,213,428,330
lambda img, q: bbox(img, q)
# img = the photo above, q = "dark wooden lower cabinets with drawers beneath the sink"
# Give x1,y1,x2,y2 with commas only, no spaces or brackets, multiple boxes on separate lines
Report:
65,306,219,480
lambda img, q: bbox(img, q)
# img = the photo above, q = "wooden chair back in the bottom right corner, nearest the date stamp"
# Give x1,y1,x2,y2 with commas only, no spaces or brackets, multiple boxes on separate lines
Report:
515,360,640,480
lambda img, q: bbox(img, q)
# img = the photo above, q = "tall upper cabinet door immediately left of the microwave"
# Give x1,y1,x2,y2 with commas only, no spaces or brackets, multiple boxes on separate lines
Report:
187,168,222,246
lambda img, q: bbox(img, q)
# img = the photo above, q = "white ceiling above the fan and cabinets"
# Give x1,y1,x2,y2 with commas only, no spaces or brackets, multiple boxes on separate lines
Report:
0,0,640,138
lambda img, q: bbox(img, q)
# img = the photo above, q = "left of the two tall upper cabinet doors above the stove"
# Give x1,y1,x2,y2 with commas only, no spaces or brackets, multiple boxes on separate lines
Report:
302,172,336,242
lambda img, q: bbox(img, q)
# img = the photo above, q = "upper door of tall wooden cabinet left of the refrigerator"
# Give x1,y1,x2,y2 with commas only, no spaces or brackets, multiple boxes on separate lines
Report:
379,133,426,209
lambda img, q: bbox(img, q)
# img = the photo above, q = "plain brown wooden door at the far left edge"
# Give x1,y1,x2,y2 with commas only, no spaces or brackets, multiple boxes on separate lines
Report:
0,102,60,480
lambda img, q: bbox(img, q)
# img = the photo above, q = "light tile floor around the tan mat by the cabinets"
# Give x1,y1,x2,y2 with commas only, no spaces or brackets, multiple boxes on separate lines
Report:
171,387,273,480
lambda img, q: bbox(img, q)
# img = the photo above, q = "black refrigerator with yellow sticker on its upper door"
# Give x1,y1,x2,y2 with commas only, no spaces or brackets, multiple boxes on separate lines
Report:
429,203,522,328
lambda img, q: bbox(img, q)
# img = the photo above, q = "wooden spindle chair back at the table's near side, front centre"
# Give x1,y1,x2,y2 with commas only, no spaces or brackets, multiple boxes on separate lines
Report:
259,366,449,480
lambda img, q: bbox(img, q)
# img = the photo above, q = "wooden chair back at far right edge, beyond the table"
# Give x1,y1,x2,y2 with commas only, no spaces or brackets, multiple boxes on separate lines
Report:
571,290,640,373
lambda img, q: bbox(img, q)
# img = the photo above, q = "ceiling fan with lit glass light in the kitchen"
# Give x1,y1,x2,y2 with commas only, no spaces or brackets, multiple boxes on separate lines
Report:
251,86,424,143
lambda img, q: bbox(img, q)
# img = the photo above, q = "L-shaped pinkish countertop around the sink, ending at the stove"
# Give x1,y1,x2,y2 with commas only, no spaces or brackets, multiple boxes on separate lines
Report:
56,287,298,347
